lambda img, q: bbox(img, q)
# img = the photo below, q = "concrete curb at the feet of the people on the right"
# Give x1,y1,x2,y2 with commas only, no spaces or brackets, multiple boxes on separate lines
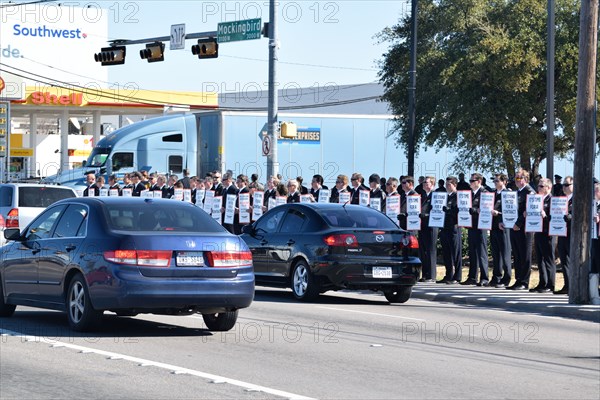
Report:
411,283,600,323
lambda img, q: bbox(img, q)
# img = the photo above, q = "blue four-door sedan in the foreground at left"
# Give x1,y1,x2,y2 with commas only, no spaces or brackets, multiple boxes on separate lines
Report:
0,197,254,331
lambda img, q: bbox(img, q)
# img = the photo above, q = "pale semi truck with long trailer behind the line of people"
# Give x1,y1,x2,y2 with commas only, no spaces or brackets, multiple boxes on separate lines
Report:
46,110,449,187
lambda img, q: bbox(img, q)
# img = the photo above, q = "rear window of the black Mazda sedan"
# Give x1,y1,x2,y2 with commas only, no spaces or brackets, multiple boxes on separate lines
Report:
319,207,398,229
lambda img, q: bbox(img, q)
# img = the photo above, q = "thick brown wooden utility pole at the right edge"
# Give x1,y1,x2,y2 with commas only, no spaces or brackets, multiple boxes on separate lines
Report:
569,0,598,304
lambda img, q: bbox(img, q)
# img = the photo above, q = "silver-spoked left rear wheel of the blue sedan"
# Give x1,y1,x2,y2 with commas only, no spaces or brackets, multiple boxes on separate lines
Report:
67,275,102,332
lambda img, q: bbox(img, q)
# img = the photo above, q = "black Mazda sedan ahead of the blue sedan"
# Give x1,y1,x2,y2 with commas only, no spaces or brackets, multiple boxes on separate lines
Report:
241,203,421,303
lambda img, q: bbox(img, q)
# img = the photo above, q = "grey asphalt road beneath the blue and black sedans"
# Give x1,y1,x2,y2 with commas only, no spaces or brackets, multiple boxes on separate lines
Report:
0,288,600,399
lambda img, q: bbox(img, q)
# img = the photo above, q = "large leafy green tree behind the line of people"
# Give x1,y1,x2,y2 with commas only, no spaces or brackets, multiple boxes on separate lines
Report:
379,0,600,176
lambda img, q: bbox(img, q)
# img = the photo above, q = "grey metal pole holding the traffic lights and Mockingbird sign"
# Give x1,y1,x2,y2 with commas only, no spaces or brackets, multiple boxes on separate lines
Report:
267,0,279,179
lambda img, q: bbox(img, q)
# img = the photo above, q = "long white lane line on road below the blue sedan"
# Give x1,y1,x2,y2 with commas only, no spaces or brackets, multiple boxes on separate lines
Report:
0,328,315,400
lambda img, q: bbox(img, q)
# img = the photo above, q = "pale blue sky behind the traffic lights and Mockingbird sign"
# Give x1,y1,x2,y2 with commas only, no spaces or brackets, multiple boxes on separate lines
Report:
105,0,410,92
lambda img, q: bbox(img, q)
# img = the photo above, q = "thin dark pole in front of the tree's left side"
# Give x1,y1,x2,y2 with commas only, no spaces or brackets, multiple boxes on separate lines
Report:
407,0,418,177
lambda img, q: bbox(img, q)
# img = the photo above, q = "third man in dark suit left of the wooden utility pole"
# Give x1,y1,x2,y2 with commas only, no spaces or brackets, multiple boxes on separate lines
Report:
507,169,535,290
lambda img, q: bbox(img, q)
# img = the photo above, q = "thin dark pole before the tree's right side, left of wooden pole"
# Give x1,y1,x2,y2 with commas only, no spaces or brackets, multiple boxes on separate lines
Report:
546,0,556,181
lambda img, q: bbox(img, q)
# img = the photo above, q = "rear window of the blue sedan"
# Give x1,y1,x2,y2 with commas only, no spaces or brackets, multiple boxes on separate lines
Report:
106,204,225,233
